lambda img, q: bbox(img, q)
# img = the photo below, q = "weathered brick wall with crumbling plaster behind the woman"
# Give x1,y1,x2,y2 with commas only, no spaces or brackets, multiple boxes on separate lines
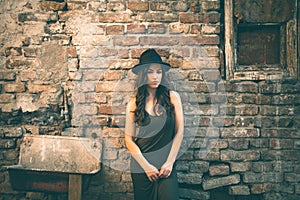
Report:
0,0,300,200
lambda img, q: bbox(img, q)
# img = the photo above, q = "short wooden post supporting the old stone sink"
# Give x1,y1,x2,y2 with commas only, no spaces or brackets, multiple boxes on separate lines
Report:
68,174,82,200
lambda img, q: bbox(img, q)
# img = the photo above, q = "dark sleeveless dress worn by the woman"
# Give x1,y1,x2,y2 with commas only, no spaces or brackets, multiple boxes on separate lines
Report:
130,111,179,200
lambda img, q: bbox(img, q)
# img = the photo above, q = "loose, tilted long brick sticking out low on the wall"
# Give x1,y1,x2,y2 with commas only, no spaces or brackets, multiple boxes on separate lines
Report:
202,174,241,190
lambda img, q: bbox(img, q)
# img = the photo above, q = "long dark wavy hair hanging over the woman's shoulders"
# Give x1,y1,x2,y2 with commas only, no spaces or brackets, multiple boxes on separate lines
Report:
134,66,174,126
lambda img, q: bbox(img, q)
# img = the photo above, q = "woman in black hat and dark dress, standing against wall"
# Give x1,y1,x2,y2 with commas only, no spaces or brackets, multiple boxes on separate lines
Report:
125,49,184,200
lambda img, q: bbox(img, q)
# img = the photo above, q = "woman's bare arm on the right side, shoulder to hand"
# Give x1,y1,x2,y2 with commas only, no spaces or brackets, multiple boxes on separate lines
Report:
159,91,184,178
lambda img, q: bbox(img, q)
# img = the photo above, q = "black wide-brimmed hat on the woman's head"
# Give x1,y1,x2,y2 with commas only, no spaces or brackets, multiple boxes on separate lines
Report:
132,49,171,74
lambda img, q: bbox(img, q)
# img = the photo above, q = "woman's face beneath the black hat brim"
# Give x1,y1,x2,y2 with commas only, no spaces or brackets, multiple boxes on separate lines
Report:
147,64,163,89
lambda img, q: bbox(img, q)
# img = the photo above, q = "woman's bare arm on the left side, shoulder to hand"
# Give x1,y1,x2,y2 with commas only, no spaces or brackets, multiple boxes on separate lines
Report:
125,100,159,181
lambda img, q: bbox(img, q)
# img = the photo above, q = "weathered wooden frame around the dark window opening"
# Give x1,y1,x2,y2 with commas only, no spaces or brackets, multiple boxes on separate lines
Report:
224,0,300,80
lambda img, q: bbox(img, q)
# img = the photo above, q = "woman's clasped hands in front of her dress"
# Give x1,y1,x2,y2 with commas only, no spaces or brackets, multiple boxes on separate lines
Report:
145,163,173,182
